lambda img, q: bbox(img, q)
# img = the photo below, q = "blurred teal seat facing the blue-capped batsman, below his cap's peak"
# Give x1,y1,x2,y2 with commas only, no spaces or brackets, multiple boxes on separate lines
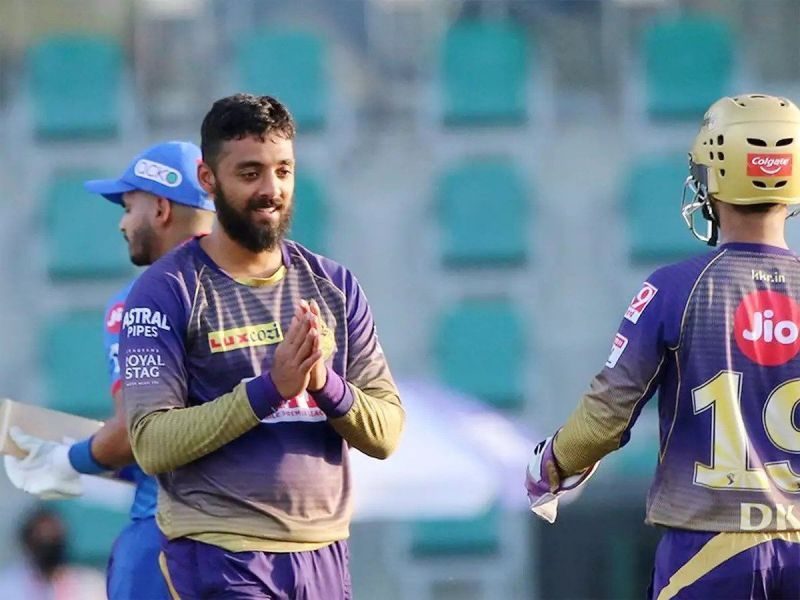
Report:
43,172,132,280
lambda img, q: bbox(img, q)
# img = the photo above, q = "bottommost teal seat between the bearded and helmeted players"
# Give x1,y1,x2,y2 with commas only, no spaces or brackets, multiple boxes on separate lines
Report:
411,507,500,558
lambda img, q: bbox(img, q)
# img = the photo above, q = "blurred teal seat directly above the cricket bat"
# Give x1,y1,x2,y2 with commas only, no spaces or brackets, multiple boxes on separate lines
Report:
39,311,113,419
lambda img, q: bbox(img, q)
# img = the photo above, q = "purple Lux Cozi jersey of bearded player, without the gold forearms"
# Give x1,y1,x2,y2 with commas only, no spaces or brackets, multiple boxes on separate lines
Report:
120,239,402,552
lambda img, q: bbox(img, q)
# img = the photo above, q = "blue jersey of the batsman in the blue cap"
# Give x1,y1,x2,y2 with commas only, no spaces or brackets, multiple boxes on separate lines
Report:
103,279,158,520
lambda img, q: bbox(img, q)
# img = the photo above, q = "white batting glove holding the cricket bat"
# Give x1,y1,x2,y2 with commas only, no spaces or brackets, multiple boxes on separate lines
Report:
3,427,83,500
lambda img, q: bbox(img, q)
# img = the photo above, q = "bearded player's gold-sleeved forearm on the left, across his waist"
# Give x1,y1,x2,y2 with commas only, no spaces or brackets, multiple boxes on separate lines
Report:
130,383,264,475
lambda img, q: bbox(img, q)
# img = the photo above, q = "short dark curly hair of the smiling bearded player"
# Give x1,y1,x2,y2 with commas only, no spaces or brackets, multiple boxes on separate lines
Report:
200,94,296,166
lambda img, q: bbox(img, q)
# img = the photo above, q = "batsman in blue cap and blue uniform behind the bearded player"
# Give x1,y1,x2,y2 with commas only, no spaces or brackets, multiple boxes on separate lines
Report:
7,142,214,600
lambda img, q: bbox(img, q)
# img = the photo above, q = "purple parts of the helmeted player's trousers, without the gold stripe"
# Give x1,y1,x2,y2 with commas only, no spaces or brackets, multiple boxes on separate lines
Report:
647,529,800,600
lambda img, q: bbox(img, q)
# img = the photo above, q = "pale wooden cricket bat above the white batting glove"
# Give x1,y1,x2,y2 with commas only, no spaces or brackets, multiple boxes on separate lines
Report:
0,398,103,458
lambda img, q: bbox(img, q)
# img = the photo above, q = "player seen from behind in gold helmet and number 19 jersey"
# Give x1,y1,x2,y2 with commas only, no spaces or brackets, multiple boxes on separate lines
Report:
526,95,800,600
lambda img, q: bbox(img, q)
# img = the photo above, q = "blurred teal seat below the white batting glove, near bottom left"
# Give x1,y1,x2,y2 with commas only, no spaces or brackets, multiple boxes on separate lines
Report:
51,499,130,570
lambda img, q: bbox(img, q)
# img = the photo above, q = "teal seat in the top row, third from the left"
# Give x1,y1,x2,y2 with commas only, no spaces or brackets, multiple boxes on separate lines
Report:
441,20,530,126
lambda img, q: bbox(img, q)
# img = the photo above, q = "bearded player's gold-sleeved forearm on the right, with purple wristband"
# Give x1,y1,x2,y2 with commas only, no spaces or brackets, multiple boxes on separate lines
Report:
312,371,405,459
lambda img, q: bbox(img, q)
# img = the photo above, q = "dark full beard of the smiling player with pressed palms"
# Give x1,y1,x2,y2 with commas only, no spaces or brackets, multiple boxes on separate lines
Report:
214,182,293,253
